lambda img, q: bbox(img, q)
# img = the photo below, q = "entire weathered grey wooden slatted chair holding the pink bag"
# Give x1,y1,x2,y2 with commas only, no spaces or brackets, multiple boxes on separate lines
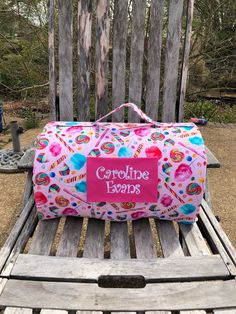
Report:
0,0,236,314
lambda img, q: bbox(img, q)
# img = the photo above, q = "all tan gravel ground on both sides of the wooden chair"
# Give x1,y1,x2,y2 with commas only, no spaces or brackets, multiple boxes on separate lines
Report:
0,125,236,247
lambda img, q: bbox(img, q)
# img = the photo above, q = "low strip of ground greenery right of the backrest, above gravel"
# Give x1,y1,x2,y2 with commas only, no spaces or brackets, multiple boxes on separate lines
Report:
184,101,236,123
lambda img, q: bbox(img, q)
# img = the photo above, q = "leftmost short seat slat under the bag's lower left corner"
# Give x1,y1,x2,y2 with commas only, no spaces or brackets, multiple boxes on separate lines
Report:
29,219,60,255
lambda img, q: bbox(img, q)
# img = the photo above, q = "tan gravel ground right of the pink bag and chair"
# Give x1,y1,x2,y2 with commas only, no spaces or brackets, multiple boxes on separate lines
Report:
202,127,236,247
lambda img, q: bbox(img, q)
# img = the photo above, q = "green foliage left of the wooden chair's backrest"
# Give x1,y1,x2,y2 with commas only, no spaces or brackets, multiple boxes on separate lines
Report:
0,0,48,98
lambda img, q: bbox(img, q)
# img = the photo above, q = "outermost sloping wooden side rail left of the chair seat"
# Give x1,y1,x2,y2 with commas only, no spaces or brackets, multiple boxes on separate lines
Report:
0,195,34,272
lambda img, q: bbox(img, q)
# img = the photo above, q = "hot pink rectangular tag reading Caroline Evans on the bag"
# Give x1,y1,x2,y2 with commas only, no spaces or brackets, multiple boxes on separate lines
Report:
87,157,158,203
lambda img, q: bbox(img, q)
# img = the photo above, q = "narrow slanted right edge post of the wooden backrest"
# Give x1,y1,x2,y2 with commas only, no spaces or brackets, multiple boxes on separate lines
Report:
177,0,194,122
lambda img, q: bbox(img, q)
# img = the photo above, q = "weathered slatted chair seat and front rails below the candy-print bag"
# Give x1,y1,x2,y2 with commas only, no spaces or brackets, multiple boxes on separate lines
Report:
0,159,236,313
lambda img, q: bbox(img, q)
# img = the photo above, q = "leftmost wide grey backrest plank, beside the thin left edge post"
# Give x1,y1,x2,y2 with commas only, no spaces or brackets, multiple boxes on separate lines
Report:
58,0,73,121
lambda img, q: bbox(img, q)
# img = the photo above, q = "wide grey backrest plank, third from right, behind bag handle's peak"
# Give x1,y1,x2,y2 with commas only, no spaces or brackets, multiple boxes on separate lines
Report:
129,0,146,122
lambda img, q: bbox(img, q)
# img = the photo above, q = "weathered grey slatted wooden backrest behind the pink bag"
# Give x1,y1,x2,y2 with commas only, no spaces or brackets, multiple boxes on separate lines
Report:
49,0,193,122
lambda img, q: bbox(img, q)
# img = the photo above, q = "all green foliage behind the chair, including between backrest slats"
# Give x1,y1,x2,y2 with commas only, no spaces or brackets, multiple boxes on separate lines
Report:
0,0,236,121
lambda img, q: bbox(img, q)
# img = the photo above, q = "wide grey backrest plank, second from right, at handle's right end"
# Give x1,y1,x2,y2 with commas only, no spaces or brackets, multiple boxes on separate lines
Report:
146,0,164,120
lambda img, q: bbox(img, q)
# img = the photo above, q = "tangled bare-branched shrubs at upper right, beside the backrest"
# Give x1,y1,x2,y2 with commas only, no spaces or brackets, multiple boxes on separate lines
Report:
189,0,236,89
